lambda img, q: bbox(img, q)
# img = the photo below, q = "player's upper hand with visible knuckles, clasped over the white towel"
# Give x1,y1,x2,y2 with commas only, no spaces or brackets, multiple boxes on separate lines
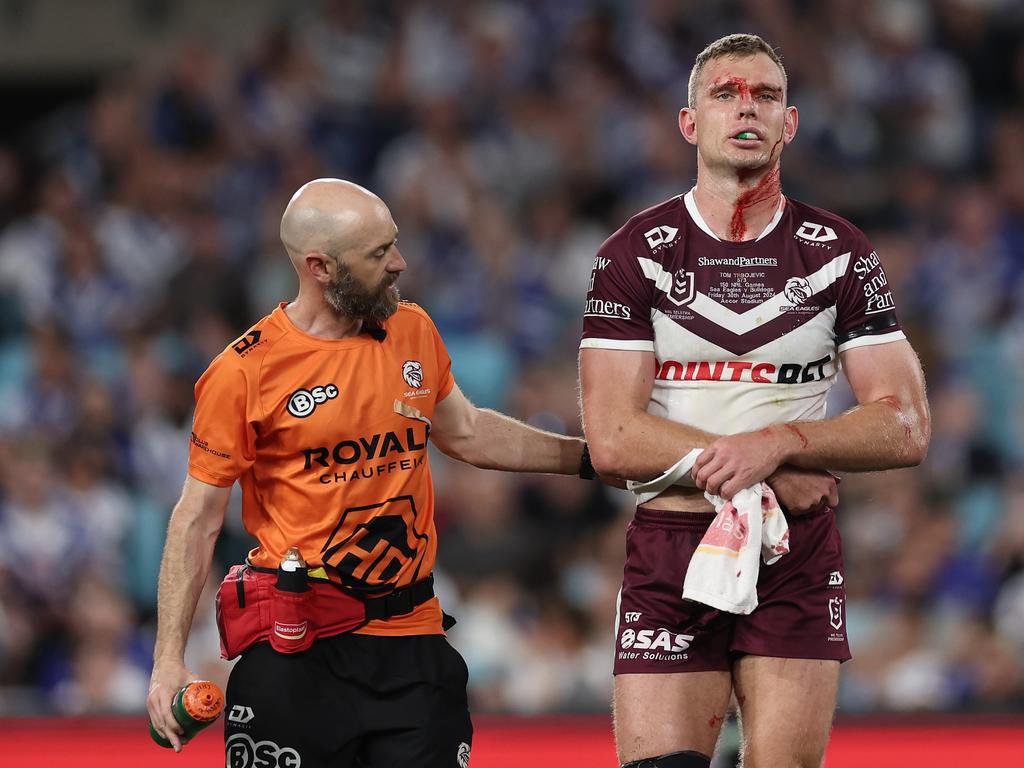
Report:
690,429,784,501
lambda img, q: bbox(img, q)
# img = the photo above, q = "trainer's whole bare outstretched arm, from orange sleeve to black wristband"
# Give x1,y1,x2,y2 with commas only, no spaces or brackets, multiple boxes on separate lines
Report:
430,384,584,475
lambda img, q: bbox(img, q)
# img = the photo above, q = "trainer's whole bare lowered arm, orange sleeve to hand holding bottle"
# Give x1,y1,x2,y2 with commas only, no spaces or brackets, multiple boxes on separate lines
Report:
146,476,231,751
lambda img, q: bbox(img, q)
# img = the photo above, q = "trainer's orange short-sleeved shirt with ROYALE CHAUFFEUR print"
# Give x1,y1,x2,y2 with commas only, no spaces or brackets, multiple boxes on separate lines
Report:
188,302,455,635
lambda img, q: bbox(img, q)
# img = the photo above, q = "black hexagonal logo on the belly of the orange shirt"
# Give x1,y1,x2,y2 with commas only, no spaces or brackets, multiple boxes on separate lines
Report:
321,496,430,594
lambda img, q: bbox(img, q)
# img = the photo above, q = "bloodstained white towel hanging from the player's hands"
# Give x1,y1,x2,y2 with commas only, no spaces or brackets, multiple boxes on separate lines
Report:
629,449,790,614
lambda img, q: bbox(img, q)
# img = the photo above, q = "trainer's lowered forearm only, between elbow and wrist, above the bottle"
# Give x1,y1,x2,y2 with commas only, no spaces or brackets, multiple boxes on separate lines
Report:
154,502,220,660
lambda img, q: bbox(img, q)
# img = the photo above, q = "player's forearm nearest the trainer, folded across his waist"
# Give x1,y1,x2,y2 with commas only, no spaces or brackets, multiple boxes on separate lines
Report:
584,411,717,480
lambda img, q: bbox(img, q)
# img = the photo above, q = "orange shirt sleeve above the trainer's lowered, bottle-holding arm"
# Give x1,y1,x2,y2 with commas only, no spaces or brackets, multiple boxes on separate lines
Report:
188,356,256,487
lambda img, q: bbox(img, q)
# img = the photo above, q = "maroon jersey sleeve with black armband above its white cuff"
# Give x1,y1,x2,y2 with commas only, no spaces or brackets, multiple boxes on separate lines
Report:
836,230,906,352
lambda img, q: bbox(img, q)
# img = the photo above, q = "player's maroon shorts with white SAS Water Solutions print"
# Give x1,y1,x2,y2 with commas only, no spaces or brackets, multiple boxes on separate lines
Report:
614,507,850,675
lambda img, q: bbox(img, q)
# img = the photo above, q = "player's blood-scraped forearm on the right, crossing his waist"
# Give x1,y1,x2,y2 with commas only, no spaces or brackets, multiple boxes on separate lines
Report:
772,397,931,472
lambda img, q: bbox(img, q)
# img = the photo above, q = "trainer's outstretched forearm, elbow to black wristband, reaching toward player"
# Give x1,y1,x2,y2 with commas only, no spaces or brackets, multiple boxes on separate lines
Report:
442,409,583,475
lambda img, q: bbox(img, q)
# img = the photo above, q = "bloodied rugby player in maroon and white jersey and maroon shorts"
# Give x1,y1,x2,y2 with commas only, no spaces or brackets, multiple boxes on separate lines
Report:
580,35,930,768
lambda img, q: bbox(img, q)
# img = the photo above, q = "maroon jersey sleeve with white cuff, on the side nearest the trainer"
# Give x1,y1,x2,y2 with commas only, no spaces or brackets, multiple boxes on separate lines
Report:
580,229,654,351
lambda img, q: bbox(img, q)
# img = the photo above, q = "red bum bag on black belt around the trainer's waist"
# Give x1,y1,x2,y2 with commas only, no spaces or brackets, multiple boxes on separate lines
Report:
216,563,434,659
